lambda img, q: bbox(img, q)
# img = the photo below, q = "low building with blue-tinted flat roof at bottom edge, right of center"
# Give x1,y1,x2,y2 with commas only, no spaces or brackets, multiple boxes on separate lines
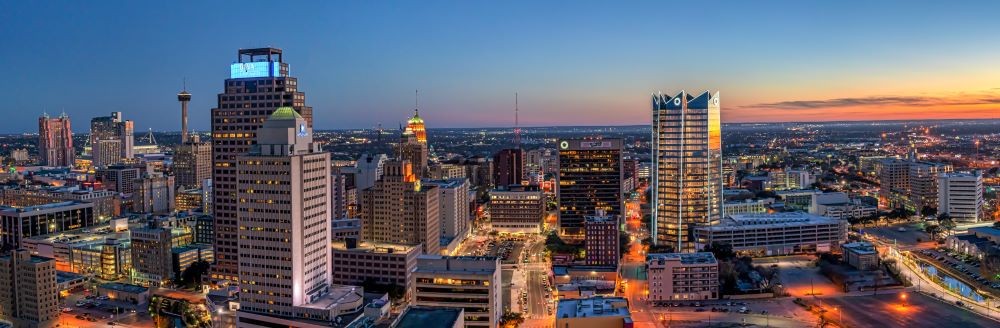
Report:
555,296,634,328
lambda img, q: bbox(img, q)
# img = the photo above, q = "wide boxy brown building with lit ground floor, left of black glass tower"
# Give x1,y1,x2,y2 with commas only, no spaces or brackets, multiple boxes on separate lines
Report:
489,186,545,233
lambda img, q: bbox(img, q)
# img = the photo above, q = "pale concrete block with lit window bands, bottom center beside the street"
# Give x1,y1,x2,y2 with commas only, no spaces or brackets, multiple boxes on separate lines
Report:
408,255,503,328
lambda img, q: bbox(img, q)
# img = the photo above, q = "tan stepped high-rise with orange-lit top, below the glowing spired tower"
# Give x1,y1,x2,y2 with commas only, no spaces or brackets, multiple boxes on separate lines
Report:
358,160,441,254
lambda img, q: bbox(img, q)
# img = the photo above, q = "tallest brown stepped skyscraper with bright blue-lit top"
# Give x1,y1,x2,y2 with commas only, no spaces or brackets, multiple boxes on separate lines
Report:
211,48,312,281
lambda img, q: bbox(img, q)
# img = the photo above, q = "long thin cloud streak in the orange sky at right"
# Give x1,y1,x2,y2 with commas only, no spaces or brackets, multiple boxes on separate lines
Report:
740,94,1000,110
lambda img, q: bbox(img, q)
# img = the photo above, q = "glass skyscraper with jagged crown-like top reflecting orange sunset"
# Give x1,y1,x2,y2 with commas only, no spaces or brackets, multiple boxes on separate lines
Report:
650,91,723,252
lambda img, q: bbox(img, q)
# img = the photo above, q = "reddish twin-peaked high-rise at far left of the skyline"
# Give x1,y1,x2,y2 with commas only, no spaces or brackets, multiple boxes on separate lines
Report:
38,113,76,166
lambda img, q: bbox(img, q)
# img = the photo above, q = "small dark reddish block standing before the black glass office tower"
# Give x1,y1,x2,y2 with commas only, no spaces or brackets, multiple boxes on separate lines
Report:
583,215,622,268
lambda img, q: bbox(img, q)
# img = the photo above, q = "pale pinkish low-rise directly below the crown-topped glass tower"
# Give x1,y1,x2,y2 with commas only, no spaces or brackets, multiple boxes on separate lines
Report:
646,252,719,301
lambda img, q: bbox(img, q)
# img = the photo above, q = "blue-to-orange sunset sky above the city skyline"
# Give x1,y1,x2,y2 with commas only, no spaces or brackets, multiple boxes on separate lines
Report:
0,1,1000,132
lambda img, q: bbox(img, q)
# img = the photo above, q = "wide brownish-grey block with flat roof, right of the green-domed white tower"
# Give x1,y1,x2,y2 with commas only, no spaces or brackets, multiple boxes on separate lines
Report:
331,240,423,288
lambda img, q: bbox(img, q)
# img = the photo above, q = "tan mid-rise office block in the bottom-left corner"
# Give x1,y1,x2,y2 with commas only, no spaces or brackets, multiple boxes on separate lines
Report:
0,249,59,327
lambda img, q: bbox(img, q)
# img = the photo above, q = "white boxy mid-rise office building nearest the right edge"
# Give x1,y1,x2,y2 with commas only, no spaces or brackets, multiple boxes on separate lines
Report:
937,172,984,222
